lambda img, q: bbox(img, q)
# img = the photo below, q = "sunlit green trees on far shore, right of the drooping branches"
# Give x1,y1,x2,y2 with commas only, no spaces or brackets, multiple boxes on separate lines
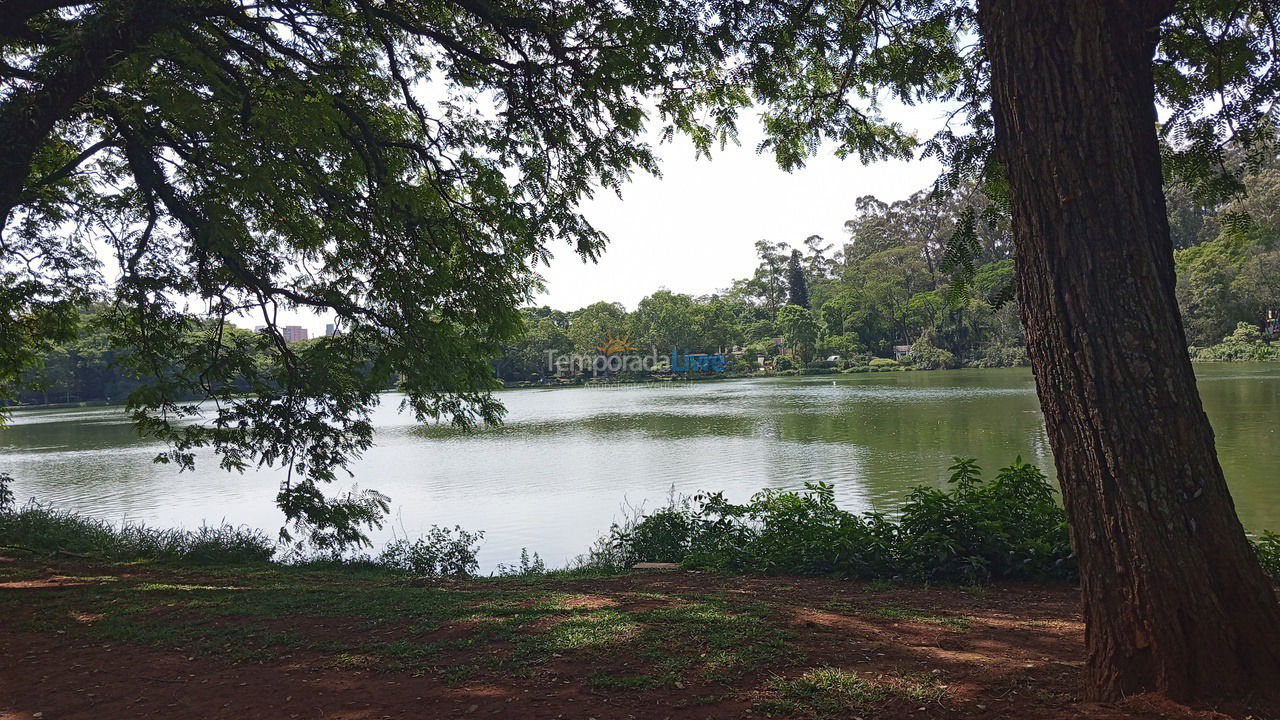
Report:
483,151,1280,379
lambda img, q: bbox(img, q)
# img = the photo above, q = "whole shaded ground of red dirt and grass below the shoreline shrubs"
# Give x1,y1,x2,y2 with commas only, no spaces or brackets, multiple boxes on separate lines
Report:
0,557,1264,720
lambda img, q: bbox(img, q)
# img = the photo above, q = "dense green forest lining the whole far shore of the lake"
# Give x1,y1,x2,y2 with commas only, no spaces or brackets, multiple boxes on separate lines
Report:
17,163,1280,404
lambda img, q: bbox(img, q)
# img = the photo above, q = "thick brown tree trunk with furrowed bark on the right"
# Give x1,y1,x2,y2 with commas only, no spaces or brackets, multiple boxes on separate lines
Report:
978,0,1280,702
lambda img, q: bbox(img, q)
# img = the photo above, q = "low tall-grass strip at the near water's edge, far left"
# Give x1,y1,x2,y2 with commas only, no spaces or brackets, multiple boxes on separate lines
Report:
0,505,275,564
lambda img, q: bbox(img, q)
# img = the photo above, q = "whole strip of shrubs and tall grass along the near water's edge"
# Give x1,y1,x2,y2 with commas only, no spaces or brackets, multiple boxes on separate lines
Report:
0,457,1280,584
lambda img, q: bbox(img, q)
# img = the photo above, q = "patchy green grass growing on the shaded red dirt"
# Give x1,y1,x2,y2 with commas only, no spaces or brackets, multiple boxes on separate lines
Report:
0,556,803,689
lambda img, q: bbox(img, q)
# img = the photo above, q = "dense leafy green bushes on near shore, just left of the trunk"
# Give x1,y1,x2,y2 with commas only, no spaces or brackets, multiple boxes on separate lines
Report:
612,457,1075,583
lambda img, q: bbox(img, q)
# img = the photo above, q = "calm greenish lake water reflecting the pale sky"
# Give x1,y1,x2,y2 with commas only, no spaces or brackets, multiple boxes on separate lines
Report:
0,364,1280,569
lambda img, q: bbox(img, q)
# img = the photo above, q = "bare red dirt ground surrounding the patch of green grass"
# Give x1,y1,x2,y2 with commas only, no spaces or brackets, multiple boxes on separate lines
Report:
0,559,1280,720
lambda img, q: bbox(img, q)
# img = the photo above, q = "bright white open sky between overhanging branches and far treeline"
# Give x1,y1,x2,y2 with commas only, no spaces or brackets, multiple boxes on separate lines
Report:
538,109,941,310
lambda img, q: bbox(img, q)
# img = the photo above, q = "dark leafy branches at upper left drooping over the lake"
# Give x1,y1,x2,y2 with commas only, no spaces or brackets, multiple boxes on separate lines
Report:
17,0,931,542
